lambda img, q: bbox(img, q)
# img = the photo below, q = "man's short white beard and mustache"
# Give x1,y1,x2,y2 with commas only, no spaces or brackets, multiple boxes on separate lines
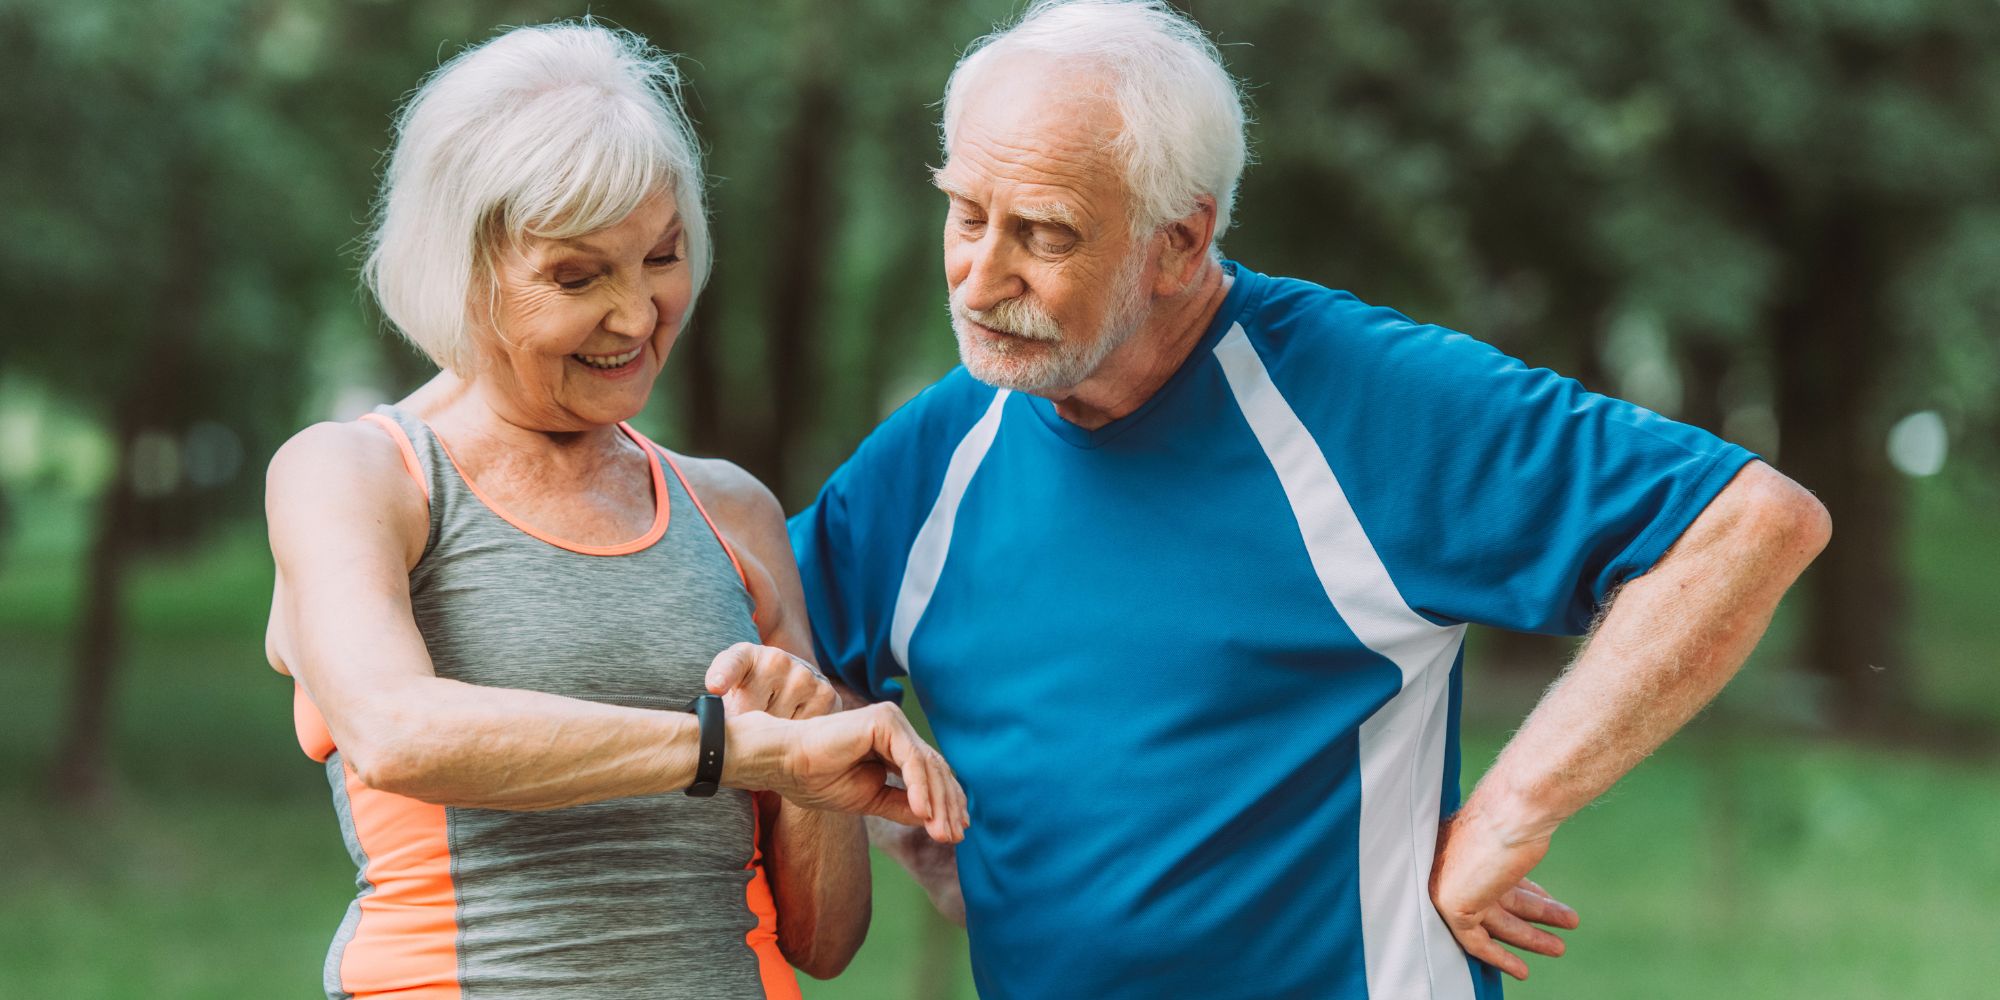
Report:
950,248,1148,396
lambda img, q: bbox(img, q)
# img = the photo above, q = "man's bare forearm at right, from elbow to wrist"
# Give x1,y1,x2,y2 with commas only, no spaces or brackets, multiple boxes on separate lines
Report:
1464,464,1830,842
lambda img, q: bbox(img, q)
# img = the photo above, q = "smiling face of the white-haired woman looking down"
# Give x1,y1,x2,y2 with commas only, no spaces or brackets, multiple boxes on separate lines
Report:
472,194,694,432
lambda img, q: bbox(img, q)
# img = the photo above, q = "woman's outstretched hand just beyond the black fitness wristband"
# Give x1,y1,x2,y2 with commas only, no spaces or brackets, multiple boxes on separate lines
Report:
722,702,970,844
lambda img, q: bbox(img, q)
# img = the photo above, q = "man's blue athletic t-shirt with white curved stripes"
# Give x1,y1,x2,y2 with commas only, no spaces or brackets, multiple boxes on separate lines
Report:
790,264,1752,1000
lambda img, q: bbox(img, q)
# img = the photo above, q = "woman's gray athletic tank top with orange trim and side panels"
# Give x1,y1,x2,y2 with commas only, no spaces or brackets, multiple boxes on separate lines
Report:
326,406,798,1000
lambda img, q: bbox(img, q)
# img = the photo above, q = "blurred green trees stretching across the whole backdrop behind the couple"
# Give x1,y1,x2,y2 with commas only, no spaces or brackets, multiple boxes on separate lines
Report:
0,0,2000,798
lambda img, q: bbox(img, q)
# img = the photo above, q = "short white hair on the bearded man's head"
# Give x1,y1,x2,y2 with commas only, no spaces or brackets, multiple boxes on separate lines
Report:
942,0,1248,242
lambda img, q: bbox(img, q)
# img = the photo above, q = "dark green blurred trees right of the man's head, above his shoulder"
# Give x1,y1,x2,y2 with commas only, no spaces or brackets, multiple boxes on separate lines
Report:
1200,0,2000,724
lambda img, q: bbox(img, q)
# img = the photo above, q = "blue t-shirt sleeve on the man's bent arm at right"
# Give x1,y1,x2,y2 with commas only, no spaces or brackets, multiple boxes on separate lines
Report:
1274,300,1756,634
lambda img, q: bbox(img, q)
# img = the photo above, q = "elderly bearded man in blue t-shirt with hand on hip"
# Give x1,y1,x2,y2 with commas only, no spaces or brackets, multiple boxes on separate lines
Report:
792,0,1830,1000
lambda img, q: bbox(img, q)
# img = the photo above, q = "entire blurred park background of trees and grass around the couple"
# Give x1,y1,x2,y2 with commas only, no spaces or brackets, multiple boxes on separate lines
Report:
0,0,2000,1000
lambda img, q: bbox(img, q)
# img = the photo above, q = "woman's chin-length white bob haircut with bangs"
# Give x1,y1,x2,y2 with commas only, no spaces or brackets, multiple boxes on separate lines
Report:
362,18,710,376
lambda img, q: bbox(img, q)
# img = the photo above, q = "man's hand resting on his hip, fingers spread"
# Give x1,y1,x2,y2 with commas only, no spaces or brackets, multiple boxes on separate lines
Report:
1430,804,1576,980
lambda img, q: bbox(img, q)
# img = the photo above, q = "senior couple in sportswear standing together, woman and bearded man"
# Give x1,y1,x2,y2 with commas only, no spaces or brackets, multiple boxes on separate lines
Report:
268,0,1828,1000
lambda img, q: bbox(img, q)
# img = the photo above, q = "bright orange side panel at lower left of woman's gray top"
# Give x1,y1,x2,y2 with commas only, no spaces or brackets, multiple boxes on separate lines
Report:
340,768,460,1000
